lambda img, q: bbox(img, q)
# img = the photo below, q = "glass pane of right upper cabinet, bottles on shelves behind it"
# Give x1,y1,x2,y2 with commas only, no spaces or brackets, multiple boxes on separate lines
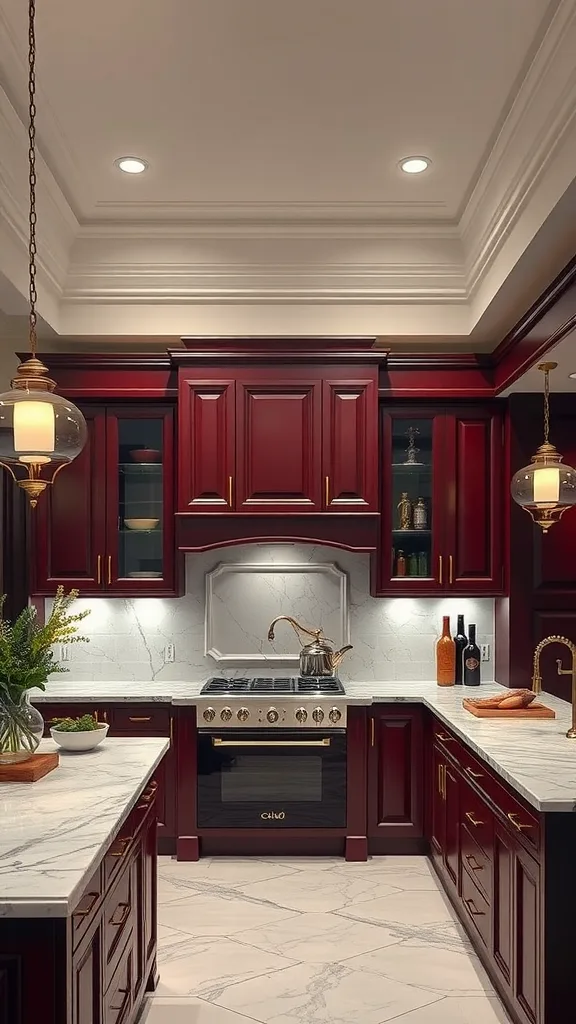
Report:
390,418,434,580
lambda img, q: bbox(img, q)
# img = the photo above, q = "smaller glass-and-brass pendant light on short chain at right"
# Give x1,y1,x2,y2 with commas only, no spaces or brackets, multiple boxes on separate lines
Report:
510,362,576,534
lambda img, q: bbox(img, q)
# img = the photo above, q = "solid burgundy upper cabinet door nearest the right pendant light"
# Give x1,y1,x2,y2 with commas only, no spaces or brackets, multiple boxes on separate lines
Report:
446,411,503,593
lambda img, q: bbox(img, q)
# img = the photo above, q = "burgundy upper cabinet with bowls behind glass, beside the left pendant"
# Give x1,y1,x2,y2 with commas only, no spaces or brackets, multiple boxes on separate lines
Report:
32,404,175,596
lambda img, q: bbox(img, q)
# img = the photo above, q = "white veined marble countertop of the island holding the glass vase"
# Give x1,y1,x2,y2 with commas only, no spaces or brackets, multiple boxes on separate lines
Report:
0,738,169,919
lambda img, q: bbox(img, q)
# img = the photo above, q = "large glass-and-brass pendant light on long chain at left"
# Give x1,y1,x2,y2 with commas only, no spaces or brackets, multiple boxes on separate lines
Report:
0,0,87,508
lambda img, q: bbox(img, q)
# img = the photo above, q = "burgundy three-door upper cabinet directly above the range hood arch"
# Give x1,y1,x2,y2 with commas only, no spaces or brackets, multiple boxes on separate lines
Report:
178,366,378,515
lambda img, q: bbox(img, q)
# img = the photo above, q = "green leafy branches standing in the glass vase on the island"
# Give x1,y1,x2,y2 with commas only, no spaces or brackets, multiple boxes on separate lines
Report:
0,587,89,754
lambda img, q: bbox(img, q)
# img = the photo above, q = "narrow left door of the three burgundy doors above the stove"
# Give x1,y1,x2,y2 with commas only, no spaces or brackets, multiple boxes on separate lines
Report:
178,377,235,512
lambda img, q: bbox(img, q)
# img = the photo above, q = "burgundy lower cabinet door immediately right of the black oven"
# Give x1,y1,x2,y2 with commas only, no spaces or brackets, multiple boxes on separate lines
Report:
368,707,423,852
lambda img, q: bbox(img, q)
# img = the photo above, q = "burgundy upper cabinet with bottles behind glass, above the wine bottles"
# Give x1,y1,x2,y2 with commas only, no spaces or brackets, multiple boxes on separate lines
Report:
377,403,503,596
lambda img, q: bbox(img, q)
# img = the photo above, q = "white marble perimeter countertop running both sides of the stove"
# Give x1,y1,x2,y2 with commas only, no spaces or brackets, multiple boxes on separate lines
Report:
32,678,576,811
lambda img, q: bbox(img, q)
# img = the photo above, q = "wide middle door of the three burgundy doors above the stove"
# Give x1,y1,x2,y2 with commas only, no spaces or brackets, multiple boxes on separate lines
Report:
236,380,321,512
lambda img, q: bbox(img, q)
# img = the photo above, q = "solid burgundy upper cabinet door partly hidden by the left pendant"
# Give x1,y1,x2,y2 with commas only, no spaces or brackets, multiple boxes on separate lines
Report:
32,409,107,595
